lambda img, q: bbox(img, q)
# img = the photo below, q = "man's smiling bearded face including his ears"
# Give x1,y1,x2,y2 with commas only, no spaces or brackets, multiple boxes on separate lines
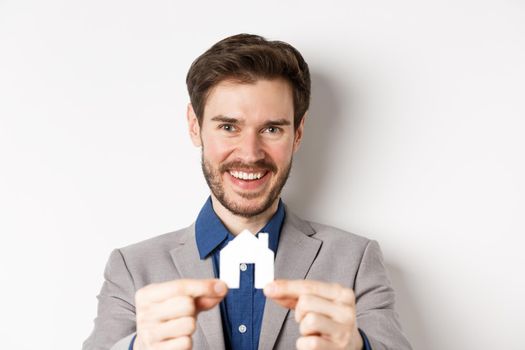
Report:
188,79,304,217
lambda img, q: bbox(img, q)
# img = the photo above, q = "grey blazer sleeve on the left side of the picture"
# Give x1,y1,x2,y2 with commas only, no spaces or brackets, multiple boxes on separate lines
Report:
82,249,136,350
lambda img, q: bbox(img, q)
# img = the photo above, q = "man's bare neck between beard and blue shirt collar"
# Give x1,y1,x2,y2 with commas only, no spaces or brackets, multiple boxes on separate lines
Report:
211,194,279,236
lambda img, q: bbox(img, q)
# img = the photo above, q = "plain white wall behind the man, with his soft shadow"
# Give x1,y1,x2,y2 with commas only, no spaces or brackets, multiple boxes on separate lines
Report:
0,0,525,350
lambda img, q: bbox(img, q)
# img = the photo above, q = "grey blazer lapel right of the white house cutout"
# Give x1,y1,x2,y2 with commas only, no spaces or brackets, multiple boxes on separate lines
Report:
259,208,321,350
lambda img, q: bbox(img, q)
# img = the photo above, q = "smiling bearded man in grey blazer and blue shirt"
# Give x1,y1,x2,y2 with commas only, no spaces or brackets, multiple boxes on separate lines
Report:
84,34,410,350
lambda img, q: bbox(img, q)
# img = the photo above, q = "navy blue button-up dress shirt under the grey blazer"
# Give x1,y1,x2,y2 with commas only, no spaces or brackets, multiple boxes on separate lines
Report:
129,197,372,350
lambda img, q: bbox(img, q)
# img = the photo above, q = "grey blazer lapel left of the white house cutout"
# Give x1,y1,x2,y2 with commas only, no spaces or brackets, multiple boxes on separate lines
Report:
170,224,225,349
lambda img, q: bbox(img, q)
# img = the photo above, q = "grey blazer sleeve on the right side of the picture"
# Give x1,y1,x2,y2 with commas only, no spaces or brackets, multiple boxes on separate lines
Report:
354,241,412,350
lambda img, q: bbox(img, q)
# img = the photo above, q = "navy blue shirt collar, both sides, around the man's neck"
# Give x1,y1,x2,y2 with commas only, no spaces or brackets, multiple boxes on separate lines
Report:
195,196,285,260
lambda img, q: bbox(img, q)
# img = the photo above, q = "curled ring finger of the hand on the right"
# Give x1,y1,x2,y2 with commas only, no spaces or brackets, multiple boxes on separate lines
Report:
299,312,351,346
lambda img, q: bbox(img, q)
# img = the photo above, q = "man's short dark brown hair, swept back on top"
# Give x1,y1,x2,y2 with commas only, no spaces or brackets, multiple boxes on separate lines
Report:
186,34,310,128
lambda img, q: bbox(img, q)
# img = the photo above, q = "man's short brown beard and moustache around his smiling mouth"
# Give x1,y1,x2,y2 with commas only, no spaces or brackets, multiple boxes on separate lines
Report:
201,150,292,218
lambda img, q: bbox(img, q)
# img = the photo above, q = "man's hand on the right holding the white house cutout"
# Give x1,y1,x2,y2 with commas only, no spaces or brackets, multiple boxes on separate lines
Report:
264,280,363,350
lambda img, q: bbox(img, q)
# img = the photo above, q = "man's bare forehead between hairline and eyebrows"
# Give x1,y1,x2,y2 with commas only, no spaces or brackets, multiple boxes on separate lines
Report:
204,78,293,121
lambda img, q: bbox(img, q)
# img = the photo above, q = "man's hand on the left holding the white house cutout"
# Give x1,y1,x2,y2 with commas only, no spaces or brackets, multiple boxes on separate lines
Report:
133,279,228,350
